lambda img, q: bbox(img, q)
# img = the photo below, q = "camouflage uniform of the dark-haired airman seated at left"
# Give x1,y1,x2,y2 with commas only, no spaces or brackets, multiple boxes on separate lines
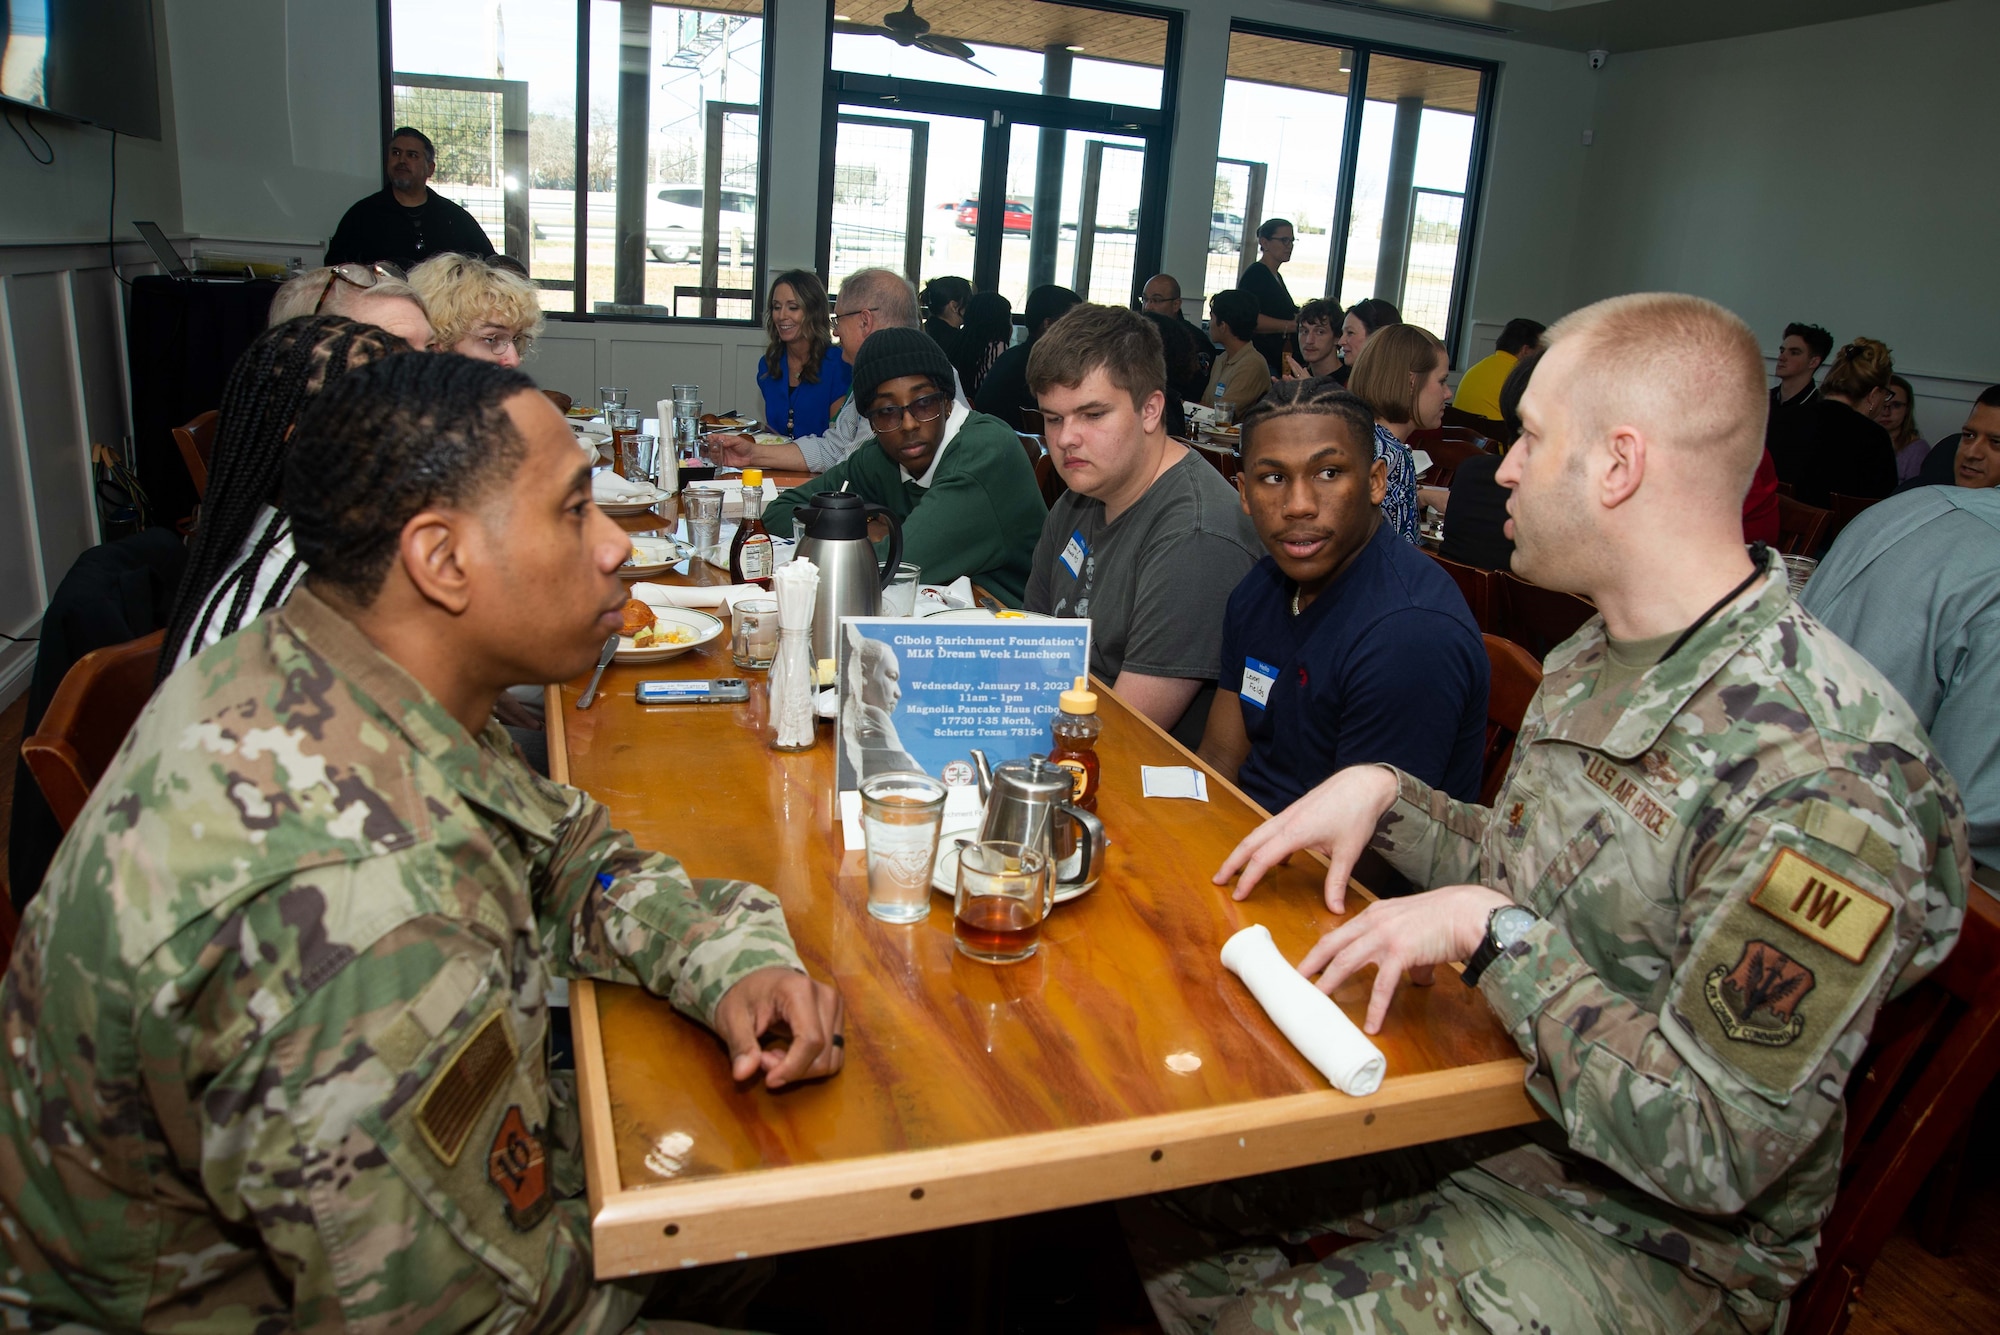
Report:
0,356,824,1331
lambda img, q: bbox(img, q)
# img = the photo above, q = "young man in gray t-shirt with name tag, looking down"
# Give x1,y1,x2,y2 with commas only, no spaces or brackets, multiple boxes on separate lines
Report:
1026,306,1264,749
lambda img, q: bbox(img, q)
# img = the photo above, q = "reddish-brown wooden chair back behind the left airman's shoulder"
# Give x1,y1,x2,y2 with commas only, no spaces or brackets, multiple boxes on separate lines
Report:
20,630,166,829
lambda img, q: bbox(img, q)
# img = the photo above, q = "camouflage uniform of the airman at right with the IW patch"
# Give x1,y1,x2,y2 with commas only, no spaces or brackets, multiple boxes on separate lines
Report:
1126,297,1970,1335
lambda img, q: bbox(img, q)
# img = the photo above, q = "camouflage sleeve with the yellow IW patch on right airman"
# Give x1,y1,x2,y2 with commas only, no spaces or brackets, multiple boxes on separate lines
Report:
1478,771,1964,1227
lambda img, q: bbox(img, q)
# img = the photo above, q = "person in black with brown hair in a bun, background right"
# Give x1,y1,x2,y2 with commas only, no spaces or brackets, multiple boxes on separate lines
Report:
1770,338,1896,508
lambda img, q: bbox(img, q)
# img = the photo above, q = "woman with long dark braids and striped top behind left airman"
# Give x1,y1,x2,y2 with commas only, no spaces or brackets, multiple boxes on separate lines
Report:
158,316,410,681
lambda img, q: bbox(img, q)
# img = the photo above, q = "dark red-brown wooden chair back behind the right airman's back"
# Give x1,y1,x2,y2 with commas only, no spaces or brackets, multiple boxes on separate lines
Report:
1786,885,2000,1335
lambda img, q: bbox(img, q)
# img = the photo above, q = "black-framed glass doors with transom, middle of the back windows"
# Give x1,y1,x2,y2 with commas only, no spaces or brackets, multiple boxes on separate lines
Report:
824,0,1178,316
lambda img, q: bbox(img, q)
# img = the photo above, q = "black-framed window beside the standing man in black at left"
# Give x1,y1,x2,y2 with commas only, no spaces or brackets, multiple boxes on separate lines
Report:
388,0,764,320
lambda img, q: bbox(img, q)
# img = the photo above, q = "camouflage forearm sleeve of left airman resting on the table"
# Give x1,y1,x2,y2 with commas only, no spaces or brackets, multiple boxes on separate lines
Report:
534,785,804,1025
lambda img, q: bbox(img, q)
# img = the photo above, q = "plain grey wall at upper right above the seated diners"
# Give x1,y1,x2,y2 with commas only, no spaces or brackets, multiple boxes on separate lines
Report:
1576,0,2000,440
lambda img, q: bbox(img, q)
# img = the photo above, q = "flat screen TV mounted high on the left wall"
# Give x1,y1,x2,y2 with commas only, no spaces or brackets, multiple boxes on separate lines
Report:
0,0,160,140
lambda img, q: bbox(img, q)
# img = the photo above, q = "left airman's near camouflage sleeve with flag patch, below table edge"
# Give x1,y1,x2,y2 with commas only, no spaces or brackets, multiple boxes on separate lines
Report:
188,903,636,1333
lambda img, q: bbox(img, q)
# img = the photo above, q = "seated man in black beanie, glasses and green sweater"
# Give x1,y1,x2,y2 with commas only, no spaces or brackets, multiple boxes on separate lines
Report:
764,325,1048,608
